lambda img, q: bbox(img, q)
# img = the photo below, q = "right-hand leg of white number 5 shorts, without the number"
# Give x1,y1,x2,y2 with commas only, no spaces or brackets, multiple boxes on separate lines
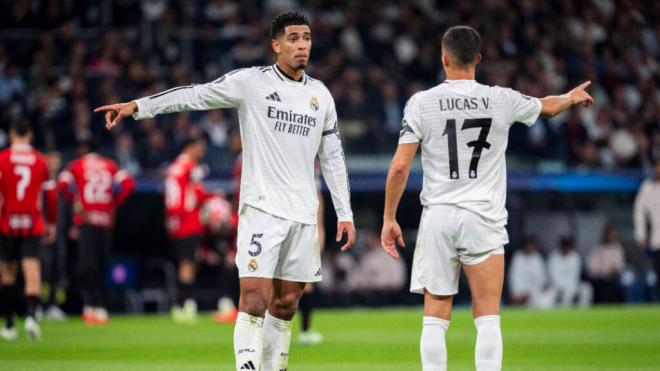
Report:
274,222,322,287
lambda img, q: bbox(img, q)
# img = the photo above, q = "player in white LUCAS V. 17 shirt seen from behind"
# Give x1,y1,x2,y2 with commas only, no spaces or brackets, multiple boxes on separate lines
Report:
381,26,593,371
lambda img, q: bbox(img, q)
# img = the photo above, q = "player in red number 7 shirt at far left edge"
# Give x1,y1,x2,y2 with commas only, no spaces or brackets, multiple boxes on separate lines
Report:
0,121,57,340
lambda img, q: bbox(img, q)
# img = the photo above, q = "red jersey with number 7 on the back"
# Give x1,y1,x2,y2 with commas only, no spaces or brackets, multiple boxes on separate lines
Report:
0,144,57,237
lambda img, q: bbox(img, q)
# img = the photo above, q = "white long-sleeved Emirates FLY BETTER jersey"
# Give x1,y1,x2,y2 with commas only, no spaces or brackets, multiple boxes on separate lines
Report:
133,65,353,224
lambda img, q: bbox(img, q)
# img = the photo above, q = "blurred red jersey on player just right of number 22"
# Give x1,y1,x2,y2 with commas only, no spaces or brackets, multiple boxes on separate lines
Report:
165,155,212,239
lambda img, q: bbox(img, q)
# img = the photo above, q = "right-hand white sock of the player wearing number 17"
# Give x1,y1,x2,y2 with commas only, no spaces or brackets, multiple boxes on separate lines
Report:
474,315,502,371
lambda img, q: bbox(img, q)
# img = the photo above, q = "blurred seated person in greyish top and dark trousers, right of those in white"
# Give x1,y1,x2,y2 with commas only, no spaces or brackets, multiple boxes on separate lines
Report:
587,224,626,303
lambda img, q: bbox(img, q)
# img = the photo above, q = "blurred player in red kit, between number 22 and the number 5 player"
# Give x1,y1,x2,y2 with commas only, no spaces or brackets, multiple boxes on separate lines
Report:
165,137,212,323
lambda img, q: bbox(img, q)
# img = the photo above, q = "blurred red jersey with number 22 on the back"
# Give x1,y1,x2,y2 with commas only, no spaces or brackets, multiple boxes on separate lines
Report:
58,153,135,228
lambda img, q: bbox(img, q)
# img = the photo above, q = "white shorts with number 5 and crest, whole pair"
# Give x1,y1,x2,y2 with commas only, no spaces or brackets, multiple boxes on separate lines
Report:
236,205,322,282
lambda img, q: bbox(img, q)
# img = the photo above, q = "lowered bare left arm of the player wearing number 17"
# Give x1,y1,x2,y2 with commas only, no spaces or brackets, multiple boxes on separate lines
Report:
380,143,419,259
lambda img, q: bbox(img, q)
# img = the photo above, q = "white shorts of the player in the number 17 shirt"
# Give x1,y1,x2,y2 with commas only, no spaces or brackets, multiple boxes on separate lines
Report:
410,205,509,296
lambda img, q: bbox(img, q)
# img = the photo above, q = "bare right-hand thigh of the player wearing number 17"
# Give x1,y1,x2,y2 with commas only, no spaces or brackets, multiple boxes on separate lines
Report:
463,251,504,318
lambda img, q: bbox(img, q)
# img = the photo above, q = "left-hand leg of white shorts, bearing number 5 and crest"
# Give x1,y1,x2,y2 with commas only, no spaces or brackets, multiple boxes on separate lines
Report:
236,206,291,279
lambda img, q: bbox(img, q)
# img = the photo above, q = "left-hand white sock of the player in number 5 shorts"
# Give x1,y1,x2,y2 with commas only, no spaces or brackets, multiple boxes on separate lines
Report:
234,312,264,370
